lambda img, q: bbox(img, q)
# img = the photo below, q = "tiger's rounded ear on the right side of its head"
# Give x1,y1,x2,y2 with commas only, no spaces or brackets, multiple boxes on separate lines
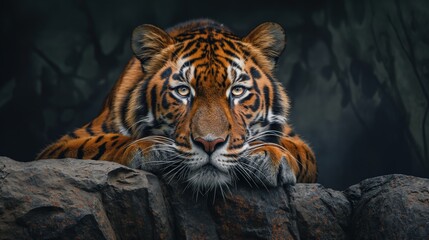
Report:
243,22,286,63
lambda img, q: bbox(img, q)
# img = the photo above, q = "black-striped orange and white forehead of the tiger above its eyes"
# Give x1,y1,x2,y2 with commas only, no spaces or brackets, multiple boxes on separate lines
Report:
173,28,247,86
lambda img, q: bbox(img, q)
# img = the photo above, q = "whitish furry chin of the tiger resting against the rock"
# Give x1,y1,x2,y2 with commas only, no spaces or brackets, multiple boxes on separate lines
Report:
187,164,233,191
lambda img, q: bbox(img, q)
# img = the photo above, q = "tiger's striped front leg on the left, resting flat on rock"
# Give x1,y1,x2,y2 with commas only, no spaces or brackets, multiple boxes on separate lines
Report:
37,134,169,172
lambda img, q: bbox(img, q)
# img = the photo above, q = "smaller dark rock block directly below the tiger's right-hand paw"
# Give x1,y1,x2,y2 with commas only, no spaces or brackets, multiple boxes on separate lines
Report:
213,187,299,239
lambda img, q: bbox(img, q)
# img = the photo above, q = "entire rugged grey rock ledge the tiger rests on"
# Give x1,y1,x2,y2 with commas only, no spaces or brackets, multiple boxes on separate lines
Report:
0,158,429,240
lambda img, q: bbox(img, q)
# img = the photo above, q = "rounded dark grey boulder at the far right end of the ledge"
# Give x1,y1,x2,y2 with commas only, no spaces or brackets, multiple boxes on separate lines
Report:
346,175,429,239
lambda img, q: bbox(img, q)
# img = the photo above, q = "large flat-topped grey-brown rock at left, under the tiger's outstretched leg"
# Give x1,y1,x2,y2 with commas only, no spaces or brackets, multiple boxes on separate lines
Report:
0,158,173,239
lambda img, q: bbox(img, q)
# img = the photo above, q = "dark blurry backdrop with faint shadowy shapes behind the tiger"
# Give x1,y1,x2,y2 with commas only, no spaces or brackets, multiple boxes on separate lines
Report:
0,0,429,189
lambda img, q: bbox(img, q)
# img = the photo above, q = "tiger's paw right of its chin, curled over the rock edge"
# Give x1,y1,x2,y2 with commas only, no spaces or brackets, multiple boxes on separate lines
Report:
237,151,296,187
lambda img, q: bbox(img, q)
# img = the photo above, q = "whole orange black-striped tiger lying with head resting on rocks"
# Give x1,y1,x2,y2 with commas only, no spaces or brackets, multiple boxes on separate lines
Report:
37,19,317,190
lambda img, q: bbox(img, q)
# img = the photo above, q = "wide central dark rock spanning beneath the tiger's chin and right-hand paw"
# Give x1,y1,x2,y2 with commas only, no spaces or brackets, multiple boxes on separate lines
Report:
150,178,299,240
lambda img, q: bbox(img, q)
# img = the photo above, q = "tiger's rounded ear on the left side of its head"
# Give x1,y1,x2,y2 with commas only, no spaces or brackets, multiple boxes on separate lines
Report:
131,24,174,68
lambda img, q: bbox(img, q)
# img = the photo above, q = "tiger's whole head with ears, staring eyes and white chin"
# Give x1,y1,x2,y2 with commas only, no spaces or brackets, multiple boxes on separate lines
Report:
128,20,289,188
